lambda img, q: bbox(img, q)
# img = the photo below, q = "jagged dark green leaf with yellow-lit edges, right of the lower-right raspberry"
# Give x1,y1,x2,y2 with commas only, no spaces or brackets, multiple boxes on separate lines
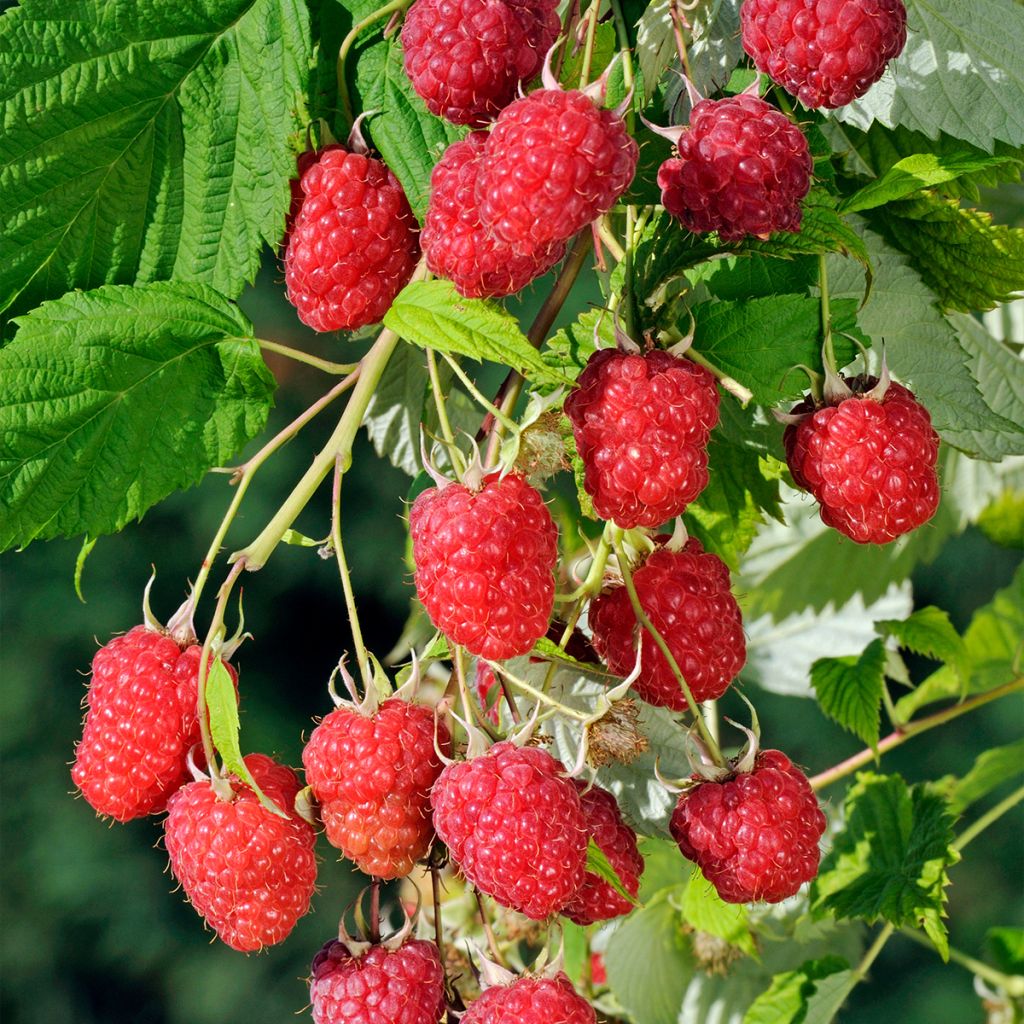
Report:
811,772,959,959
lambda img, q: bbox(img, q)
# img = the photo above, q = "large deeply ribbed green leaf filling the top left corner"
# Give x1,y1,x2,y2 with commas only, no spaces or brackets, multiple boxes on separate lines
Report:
0,0,310,312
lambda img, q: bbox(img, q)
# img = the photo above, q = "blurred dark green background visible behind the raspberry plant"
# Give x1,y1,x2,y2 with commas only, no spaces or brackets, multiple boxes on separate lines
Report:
0,222,1024,1024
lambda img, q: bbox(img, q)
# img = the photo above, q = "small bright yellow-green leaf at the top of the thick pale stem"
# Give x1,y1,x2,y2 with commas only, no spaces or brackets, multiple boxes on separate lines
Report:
384,281,571,385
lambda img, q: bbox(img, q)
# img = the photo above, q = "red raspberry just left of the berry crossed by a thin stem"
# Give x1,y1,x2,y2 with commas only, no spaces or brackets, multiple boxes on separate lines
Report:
409,473,558,660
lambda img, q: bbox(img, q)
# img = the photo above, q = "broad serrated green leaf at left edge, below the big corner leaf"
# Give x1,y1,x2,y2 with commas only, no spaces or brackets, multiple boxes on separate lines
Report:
0,283,274,550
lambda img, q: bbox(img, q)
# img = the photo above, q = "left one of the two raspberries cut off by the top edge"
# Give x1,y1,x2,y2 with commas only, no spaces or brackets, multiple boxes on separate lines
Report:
401,0,561,126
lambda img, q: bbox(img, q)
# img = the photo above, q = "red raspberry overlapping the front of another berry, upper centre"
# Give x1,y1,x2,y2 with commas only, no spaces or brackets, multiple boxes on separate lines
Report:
476,89,639,254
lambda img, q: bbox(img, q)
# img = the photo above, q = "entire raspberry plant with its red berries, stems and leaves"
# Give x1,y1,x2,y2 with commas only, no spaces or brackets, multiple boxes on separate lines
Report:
0,0,1024,1024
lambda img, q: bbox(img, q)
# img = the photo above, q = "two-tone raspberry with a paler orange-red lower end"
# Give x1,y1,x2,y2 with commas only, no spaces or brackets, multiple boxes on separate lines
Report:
302,698,452,879
